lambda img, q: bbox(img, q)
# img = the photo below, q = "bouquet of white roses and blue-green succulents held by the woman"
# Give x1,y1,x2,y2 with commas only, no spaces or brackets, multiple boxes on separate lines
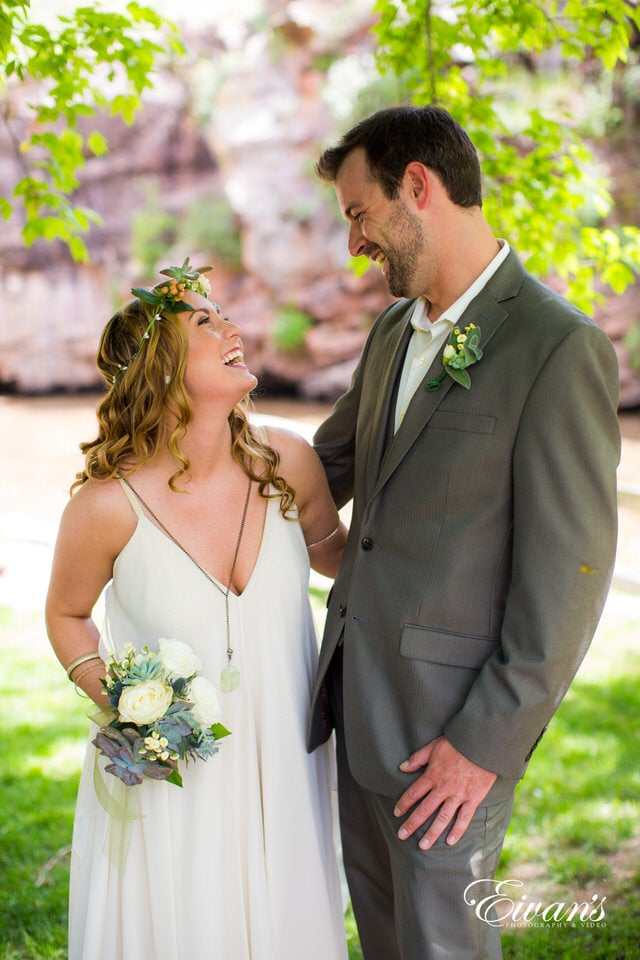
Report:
92,638,229,787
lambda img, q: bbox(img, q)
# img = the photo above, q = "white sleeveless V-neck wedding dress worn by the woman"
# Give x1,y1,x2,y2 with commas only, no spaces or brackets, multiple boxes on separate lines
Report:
69,485,347,960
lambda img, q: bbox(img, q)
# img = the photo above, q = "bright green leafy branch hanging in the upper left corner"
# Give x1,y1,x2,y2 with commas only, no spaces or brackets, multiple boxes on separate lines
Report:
0,0,185,260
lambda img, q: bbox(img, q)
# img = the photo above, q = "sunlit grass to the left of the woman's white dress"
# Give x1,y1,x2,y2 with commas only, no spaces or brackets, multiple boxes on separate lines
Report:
0,610,87,960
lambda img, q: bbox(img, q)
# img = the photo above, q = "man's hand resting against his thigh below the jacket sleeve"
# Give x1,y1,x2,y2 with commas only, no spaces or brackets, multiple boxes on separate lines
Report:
393,737,497,850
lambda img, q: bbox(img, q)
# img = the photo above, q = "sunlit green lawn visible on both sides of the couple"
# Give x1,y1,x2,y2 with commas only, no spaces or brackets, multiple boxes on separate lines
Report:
0,589,640,960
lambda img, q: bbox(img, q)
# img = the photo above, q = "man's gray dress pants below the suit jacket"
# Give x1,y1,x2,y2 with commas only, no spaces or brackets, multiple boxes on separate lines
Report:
327,647,513,960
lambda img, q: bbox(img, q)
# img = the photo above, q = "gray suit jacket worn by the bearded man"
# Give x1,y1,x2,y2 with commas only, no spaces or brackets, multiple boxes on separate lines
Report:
309,251,620,802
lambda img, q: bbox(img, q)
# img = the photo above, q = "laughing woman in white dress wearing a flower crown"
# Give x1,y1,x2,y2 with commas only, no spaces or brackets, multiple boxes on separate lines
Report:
46,259,346,960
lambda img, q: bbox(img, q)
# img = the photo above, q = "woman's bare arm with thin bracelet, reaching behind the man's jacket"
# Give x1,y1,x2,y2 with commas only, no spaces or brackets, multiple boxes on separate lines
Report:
268,427,347,577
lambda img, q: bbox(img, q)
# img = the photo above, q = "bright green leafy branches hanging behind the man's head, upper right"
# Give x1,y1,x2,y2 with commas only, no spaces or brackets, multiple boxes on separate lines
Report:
374,0,640,310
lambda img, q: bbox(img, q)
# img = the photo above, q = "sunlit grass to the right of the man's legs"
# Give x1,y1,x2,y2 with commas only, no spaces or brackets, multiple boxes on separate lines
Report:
498,606,640,960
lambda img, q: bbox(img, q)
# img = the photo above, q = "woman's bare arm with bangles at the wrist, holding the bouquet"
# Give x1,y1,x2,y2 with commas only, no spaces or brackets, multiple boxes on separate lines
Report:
45,480,135,706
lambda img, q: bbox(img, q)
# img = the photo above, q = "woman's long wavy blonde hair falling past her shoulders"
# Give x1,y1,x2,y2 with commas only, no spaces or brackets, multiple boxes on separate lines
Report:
71,300,295,517
